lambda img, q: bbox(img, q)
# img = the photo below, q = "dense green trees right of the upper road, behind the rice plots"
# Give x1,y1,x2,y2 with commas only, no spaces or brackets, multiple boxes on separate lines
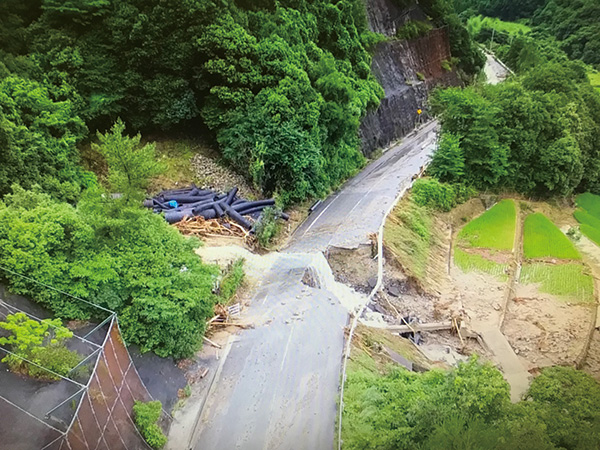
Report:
417,0,600,206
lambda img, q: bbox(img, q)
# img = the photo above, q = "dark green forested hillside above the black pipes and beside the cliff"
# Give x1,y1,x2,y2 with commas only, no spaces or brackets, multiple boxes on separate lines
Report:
0,0,482,204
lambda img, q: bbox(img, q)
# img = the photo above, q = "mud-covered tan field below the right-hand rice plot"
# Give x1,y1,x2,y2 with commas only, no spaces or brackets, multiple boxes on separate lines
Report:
503,284,593,369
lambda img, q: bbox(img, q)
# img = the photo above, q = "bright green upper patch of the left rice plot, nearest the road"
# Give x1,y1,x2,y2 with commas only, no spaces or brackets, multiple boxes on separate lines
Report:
458,199,517,250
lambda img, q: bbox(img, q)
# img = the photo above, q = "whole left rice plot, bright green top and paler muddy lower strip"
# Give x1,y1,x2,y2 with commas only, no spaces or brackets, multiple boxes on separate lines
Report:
454,199,516,281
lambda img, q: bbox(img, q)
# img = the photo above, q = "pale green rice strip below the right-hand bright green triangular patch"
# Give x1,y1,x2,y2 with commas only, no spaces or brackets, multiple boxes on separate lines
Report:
520,263,594,303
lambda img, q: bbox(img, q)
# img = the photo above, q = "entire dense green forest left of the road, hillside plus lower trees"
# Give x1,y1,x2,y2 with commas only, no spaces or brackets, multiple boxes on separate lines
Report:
0,0,482,357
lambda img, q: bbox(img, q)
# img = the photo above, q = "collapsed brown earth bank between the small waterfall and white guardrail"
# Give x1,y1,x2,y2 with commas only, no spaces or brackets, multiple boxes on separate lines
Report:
325,245,377,293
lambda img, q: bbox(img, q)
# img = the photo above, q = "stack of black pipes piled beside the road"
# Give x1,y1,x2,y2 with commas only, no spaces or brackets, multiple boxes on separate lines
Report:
144,185,289,230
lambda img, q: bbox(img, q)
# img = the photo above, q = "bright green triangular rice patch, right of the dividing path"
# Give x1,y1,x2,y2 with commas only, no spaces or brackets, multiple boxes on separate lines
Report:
523,213,581,259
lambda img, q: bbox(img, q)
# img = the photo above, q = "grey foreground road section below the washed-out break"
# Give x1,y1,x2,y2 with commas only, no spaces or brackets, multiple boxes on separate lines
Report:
195,255,352,450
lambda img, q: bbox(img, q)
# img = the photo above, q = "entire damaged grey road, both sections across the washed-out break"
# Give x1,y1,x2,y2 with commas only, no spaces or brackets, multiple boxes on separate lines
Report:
191,123,436,450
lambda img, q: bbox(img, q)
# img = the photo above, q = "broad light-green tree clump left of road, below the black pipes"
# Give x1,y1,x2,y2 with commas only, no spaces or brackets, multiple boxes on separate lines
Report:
0,188,219,358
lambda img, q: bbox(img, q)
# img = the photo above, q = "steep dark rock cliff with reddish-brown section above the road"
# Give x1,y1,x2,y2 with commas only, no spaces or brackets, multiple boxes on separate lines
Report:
360,0,459,156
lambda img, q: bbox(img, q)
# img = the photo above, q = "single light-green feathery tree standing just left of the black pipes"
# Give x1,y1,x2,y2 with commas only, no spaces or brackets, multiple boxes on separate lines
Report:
92,119,163,202
